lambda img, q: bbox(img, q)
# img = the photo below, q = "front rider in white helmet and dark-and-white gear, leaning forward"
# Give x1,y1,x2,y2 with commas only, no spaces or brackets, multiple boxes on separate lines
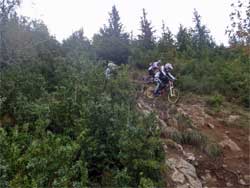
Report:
154,63,176,96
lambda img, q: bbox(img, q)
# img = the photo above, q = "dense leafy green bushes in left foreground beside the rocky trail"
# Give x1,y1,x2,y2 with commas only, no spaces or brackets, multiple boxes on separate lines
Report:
0,59,164,187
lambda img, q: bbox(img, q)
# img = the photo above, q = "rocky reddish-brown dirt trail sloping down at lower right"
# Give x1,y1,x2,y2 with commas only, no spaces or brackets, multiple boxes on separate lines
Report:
133,75,250,188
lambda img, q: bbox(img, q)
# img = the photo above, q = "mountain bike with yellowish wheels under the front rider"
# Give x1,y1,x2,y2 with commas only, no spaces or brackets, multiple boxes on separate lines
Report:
144,80,180,104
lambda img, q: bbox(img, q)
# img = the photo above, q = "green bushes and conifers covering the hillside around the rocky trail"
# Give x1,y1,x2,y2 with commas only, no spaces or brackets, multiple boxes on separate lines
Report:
0,0,250,188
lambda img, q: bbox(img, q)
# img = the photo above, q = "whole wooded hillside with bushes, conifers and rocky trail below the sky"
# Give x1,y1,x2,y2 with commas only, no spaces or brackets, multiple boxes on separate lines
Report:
0,0,250,188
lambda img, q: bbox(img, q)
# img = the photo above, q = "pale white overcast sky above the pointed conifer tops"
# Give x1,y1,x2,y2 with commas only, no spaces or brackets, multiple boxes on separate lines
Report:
19,0,236,44
